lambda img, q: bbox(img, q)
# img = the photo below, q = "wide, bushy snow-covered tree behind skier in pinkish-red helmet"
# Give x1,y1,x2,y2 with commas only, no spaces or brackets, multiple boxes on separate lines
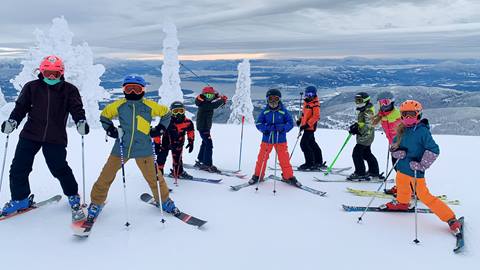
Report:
10,17,109,127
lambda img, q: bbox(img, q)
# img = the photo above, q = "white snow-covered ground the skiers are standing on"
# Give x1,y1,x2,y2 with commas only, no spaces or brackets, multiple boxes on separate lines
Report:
0,124,480,269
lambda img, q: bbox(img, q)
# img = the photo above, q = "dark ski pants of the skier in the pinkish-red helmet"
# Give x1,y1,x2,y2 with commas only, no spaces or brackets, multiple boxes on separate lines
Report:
10,138,78,200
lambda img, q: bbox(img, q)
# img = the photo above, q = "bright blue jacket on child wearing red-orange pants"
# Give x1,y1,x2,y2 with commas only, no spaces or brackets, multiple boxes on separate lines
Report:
255,102,293,144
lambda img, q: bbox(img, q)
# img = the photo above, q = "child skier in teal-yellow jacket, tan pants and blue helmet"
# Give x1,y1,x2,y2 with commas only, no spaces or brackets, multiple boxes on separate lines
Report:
87,76,178,223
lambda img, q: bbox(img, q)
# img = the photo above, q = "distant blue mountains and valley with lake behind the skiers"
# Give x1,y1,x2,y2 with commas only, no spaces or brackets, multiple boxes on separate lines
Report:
0,57,480,135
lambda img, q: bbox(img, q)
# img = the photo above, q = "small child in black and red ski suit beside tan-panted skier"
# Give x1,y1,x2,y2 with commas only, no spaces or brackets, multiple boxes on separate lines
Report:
155,101,195,179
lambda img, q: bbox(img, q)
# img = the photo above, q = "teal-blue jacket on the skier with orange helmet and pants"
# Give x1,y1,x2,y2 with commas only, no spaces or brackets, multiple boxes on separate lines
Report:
394,119,440,178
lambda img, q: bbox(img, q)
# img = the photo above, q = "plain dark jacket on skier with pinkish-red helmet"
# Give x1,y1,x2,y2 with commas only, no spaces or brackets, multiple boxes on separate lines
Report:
10,74,86,145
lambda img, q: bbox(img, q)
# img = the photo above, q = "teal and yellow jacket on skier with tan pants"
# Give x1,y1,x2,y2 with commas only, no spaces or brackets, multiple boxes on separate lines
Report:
100,98,171,159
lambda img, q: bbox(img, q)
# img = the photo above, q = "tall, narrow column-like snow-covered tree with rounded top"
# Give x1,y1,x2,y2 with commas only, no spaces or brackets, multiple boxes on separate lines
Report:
158,20,183,106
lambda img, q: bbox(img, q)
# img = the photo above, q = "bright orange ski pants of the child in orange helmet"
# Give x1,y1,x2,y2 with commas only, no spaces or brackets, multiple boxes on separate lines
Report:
396,172,455,222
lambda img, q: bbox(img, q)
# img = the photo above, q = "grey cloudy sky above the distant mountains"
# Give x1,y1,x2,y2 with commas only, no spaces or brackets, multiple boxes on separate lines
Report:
0,0,480,59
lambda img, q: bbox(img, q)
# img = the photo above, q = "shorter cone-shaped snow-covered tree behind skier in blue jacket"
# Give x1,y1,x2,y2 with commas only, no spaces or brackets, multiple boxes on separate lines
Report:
228,59,255,124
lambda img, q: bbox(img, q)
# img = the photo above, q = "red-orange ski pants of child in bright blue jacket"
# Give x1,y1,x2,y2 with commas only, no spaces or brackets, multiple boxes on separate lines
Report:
255,142,293,179
